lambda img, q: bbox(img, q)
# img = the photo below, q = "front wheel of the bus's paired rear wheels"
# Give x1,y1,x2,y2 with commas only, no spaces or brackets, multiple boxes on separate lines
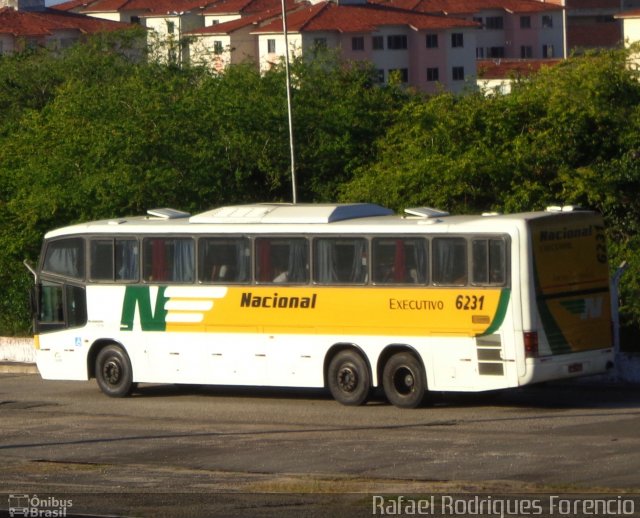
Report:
327,351,371,406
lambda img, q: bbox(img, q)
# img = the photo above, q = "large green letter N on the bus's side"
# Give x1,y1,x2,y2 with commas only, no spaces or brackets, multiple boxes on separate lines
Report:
120,286,169,331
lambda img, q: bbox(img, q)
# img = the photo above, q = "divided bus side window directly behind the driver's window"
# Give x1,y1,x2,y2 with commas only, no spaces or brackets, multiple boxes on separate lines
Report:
89,238,138,282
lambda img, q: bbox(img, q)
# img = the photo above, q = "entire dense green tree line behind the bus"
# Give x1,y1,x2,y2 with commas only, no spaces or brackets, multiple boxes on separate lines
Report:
0,33,640,350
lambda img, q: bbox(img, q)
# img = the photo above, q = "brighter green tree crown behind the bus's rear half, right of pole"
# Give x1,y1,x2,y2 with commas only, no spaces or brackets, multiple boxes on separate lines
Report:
341,47,640,342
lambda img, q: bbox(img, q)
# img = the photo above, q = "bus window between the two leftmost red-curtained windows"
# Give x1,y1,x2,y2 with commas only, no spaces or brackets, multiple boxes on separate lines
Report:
198,237,251,283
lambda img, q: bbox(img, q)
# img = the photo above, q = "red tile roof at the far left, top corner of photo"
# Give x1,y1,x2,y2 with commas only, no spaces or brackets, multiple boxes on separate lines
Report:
0,8,130,37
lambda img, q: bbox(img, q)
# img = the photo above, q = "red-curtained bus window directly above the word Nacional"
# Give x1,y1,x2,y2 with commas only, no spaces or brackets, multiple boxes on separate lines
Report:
255,237,309,284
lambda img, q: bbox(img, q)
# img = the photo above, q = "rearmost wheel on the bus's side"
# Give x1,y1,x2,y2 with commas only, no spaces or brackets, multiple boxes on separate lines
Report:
382,352,427,408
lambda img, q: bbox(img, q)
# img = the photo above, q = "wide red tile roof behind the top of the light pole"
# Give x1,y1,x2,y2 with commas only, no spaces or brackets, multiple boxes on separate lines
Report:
255,2,477,33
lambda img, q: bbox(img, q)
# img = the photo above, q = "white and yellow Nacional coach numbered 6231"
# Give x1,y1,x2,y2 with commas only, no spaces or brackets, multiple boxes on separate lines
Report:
32,203,614,408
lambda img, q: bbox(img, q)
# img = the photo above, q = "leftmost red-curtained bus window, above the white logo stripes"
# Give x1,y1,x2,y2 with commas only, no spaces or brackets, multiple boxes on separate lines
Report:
142,237,195,282
